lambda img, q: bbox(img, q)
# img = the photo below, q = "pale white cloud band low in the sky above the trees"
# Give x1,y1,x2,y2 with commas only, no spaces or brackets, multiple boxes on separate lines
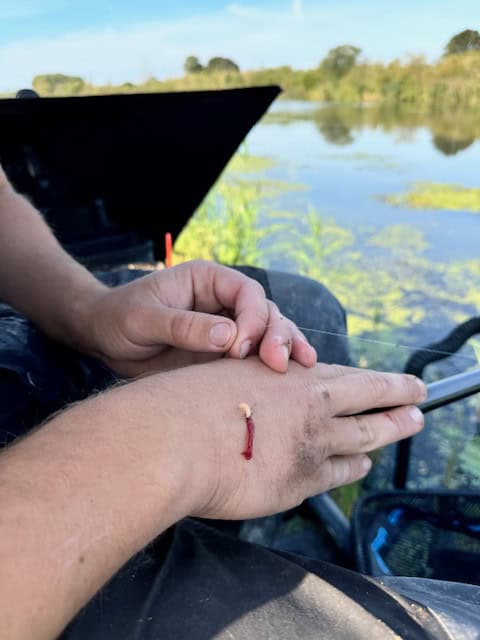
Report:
0,0,478,91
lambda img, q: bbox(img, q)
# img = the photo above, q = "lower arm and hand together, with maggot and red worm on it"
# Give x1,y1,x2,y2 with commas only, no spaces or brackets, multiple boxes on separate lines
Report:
0,357,426,640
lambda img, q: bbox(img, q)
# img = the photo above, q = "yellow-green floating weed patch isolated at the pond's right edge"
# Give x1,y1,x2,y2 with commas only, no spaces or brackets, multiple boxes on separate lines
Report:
385,182,480,213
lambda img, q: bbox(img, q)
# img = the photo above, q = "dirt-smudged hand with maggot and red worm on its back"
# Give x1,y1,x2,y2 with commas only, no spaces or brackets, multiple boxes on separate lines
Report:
136,358,426,519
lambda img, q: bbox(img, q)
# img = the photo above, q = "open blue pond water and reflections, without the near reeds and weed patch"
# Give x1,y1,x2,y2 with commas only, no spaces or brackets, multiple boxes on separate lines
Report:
247,101,480,486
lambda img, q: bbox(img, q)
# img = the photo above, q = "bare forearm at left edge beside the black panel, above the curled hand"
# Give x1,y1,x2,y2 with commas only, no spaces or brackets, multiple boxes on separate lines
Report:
0,180,105,346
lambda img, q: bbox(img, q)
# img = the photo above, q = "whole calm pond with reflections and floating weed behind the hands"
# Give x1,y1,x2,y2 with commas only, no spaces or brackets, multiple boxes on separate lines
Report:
177,101,480,487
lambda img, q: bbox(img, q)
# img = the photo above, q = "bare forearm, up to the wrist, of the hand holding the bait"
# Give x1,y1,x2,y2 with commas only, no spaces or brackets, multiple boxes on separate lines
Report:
0,372,198,640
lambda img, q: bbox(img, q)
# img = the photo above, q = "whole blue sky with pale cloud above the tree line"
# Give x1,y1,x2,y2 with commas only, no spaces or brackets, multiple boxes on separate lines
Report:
0,0,480,92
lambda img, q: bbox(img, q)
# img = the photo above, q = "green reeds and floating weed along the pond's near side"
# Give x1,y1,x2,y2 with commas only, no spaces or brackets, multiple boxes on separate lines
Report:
175,154,480,504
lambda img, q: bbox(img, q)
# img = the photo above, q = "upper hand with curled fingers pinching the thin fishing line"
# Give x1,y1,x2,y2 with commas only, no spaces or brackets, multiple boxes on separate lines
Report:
77,261,316,376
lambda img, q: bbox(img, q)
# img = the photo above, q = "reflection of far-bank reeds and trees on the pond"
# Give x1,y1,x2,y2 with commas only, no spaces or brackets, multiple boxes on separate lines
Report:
264,103,480,156
